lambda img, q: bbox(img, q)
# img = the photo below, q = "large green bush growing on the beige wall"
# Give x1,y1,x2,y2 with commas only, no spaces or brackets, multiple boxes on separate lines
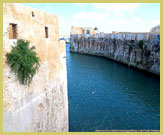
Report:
6,39,40,85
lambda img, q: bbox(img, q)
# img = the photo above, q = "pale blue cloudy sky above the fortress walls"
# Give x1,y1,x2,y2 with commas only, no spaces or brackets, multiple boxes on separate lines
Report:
23,3,160,34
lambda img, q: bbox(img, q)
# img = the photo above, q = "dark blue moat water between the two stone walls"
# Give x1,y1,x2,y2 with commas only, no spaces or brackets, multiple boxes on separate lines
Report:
66,45,160,132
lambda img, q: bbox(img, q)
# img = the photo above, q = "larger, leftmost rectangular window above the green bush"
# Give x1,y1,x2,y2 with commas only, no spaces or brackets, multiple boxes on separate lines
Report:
9,24,17,39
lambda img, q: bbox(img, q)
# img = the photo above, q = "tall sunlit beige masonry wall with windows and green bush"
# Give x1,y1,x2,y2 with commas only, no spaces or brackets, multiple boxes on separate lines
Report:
3,4,68,132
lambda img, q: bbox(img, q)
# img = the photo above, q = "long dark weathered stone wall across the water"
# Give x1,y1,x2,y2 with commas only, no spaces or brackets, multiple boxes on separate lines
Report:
70,33,160,75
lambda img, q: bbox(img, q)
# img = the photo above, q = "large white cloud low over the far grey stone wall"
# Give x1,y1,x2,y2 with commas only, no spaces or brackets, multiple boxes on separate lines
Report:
72,11,142,33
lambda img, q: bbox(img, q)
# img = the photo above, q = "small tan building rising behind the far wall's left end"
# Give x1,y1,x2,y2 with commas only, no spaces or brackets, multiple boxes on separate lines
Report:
71,26,99,34
